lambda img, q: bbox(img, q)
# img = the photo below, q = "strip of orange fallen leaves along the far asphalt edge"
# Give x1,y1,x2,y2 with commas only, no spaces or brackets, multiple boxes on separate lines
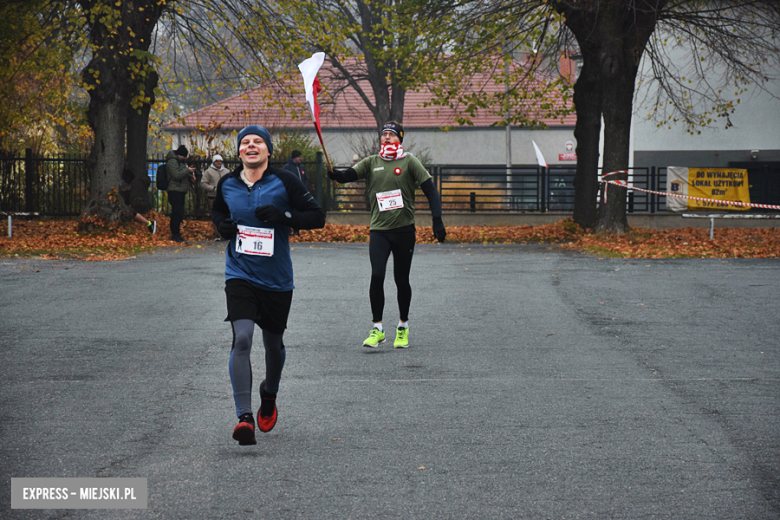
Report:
0,213,780,261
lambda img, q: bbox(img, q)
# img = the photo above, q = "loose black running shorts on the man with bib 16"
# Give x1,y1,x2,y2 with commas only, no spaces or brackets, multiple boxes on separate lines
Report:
225,278,292,334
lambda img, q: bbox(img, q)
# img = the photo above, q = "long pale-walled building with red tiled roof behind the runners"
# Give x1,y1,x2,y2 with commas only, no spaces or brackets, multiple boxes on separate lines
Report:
163,58,576,166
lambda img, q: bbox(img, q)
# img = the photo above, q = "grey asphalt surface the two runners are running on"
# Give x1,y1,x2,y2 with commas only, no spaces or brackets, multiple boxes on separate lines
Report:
0,244,780,520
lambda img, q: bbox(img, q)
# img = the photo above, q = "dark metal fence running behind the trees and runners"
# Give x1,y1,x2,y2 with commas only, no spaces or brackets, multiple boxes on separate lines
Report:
0,150,666,218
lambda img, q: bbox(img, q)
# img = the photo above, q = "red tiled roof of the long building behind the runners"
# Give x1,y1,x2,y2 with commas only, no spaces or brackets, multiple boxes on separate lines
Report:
163,57,576,131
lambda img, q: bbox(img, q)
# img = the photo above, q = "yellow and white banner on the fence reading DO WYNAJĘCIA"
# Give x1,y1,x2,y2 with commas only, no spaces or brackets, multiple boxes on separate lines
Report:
666,166,750,211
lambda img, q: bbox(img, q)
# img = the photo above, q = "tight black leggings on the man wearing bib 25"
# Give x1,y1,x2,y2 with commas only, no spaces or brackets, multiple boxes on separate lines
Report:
368,227,417,323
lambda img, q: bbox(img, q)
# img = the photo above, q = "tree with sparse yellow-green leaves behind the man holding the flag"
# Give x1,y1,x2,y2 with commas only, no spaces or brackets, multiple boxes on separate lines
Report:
244,0,512,129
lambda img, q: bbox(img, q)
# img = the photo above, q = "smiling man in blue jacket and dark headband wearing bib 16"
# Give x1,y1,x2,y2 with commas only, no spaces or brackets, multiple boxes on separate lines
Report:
211,125,325,445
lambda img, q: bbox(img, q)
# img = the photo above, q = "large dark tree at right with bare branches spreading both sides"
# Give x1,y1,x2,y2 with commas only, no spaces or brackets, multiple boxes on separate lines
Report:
428,0,780,233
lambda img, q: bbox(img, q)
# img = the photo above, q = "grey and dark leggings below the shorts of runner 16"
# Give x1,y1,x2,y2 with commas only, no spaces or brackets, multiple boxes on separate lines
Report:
228,320,287,417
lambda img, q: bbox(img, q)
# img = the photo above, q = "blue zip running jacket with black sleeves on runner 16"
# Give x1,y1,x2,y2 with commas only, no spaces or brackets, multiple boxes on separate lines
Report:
211,165,325,291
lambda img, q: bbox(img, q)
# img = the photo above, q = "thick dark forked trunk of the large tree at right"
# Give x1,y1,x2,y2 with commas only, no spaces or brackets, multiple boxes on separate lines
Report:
552,0,667,233
